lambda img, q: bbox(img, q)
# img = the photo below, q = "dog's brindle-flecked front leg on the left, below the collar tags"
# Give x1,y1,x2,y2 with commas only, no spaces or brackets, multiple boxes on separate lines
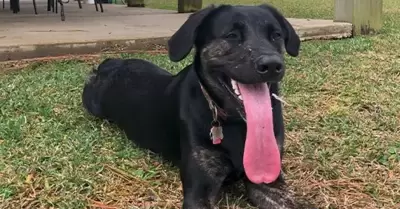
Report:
180,147,232,209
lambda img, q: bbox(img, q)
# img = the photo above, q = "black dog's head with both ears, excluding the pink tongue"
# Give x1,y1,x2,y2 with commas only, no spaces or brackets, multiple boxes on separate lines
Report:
168,5,300,116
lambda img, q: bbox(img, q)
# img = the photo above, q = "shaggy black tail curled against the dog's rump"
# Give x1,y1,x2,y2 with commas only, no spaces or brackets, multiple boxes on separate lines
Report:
82,59,115,119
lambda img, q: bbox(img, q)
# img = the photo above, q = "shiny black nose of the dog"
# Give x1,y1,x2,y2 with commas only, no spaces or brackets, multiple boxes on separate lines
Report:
257,55,283,74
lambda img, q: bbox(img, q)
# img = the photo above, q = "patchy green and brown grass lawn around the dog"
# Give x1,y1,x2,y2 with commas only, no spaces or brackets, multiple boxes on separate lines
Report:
0,0,400,209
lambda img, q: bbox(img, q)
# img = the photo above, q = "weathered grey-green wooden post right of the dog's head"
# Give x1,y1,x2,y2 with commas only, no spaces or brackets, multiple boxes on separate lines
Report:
334,0,383,35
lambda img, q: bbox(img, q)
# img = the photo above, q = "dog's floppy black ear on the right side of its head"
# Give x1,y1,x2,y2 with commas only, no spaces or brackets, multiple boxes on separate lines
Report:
259,4,300,57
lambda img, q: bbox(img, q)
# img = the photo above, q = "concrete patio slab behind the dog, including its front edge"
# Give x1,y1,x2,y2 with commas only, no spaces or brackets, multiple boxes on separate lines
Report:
0,0,351,61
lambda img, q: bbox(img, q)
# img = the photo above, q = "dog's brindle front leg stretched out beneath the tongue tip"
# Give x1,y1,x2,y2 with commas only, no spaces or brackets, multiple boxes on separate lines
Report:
244,180,316,209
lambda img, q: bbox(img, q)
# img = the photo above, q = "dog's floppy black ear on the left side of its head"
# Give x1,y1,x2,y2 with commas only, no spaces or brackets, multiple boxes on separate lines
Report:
168,4,215,62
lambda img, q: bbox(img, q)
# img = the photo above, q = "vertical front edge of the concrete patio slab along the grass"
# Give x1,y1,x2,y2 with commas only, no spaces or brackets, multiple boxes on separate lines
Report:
0,23,352,61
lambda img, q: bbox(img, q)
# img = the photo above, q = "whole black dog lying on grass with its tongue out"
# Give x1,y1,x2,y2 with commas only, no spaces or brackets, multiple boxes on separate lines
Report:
83,5,318,209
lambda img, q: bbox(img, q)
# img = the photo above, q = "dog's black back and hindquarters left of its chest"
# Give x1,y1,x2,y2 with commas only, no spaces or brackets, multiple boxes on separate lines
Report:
82,59,179,161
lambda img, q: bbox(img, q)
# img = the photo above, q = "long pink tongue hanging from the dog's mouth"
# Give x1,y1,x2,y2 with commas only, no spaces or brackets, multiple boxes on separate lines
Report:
238,83,281,184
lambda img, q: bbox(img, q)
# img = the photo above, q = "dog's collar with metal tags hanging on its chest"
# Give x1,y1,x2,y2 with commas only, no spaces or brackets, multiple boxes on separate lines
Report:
199,83,227,144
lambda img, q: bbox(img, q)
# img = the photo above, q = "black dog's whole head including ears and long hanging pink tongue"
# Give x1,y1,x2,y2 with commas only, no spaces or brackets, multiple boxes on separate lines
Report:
168,5,300,183
